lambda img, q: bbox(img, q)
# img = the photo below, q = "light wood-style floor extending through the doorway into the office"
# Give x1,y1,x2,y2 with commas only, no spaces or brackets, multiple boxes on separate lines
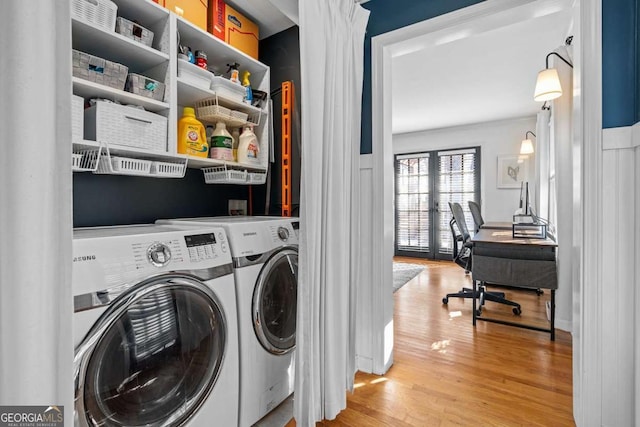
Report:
287,258,575,427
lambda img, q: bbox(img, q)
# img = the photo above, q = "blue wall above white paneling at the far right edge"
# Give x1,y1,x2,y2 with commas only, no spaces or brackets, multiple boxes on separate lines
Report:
602,0,640,128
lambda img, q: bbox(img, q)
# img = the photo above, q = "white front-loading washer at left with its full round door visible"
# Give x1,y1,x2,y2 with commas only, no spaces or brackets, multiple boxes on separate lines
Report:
73,225,240,427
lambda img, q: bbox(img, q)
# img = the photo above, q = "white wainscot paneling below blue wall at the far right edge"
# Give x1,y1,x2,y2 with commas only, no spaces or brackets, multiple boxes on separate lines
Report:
600,125,640,426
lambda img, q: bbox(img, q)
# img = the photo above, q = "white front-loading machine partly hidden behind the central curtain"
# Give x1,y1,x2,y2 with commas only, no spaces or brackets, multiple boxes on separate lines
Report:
158,216,299,427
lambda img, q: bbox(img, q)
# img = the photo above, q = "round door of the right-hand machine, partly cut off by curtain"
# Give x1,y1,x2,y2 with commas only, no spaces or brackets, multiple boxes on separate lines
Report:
252,248,298,354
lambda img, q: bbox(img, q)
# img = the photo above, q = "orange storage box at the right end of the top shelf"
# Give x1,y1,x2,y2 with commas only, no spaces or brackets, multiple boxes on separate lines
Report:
207,0,260,59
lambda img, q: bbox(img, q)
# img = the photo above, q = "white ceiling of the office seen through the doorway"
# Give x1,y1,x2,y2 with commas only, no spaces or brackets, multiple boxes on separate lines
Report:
392,2,571,134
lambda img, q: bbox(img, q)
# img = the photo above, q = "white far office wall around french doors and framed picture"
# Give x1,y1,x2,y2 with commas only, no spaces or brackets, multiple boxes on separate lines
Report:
393,116,536,222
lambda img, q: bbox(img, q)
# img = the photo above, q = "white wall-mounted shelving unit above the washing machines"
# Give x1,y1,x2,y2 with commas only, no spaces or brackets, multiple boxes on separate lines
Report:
70,0,270,184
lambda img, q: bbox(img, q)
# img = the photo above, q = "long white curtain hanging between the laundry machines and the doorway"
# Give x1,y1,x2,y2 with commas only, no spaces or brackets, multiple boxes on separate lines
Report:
294,0,369,427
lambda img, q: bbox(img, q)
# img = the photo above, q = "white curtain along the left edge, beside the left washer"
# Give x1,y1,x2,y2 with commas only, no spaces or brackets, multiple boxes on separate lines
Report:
0,0,73,426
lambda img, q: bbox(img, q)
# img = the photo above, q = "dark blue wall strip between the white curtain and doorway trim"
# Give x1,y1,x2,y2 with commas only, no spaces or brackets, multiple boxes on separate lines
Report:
360,0,483,154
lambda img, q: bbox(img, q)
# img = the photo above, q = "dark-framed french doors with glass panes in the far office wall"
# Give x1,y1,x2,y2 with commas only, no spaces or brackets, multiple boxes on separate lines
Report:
395,147,480,259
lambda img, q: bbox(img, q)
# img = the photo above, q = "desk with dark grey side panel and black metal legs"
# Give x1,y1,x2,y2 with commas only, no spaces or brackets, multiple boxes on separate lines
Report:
471,228,558,341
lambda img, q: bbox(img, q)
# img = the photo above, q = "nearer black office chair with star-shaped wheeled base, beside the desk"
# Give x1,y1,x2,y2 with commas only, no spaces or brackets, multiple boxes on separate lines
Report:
442,203,522,315
